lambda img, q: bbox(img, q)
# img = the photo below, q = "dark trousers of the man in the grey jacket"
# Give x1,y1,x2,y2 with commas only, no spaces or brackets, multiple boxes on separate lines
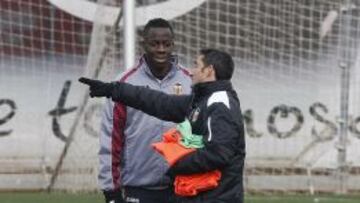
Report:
123,187,173,203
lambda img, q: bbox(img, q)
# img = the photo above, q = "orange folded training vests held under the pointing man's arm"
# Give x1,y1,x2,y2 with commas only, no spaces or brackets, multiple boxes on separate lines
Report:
152,128,221,196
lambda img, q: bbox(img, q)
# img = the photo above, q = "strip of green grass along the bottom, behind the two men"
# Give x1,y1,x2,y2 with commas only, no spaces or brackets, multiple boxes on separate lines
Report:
0,193,360,203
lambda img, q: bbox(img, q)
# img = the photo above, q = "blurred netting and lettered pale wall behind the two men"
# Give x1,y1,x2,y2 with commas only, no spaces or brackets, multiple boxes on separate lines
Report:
0,0,360,202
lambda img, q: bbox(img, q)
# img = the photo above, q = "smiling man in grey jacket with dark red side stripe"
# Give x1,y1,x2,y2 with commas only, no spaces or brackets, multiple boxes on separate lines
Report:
95,18,191,203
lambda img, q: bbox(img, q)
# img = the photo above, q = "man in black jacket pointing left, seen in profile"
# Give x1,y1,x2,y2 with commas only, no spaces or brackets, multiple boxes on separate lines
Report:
79,49,245,203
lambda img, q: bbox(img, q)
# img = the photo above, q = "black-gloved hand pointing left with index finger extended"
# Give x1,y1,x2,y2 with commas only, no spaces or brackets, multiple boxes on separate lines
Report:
79,77,115,98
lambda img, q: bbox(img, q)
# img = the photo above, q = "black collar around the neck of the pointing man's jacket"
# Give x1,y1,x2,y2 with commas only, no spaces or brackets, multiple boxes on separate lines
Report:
193,80,233,97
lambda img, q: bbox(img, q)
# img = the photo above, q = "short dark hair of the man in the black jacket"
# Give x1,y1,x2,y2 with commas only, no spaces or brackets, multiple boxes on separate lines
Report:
200,49,234,80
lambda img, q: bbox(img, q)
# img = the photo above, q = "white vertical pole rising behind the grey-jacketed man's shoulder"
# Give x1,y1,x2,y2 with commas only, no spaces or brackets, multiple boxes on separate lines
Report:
123,0,136,69
